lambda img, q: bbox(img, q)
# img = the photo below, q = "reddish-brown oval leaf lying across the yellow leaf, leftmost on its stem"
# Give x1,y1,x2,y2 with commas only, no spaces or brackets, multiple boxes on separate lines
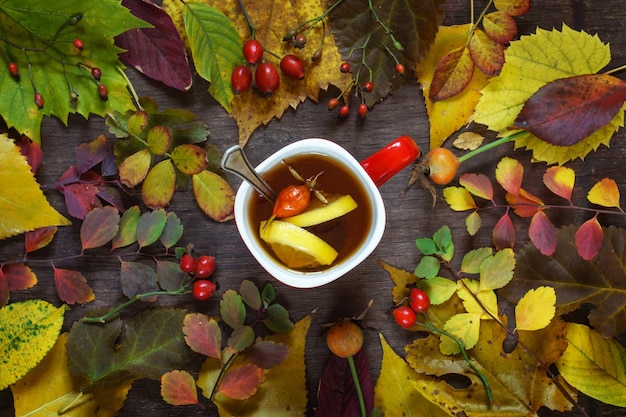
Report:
429,47,474,101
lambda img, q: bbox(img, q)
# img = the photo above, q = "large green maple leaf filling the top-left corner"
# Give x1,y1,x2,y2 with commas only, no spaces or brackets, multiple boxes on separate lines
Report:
0,0,147,142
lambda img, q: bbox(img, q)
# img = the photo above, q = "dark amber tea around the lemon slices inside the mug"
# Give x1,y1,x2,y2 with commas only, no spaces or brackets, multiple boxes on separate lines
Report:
248,154,373,271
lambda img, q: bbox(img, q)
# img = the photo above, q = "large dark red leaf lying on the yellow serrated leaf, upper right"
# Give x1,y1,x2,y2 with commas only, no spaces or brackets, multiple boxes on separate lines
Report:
514,74,626,146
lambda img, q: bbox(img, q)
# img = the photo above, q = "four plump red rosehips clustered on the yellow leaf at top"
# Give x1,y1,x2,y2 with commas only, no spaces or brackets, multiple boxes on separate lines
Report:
230,39,304,97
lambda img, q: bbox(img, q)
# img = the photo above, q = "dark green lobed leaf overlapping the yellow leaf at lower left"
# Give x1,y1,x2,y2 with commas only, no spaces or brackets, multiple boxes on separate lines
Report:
67,308,192,386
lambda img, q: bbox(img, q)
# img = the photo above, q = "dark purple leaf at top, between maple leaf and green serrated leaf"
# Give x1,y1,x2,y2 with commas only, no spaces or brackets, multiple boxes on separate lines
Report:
115,0,192,91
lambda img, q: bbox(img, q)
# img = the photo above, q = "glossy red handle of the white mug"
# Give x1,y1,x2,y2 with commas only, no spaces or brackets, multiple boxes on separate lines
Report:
361,136,422,187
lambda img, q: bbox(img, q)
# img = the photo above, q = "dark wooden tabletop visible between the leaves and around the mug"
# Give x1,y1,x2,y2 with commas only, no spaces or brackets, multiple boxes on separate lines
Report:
0,0,626,417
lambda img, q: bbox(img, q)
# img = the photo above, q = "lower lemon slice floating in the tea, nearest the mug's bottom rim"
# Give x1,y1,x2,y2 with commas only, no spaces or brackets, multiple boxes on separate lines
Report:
259,220,338,269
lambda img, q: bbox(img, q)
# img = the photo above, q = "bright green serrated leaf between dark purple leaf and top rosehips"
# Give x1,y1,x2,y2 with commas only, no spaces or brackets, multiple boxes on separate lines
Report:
183,2,243,112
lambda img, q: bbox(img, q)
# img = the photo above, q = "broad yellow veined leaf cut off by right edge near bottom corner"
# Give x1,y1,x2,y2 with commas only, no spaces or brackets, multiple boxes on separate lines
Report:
556,323,626,407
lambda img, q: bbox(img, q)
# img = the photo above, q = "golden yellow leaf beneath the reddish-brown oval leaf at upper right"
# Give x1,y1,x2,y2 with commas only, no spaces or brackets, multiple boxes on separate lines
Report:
417,24,487,149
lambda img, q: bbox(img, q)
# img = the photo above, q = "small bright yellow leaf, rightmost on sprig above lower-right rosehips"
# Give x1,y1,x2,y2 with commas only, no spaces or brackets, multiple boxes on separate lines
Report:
515,286,556,331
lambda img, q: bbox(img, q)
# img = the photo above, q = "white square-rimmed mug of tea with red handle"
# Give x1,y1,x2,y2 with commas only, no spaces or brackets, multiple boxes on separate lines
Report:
225,136,420,288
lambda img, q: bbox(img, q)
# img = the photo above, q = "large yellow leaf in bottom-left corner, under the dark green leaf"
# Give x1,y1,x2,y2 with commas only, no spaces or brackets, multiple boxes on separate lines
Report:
11,333,133,417
